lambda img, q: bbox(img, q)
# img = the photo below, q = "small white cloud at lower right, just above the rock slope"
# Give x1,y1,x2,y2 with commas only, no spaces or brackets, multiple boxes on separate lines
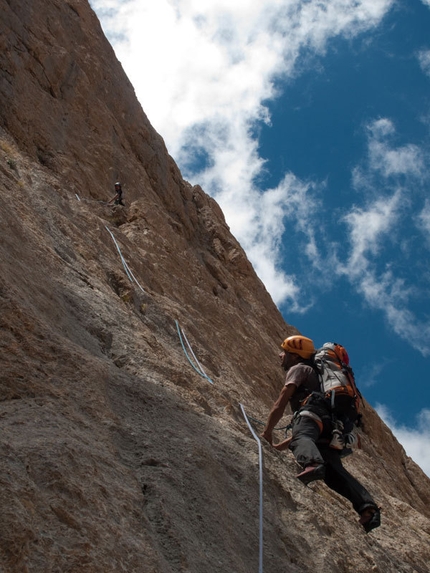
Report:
376,404,430,477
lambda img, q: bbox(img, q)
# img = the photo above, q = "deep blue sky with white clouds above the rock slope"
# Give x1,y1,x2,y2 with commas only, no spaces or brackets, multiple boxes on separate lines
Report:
91,0,430,475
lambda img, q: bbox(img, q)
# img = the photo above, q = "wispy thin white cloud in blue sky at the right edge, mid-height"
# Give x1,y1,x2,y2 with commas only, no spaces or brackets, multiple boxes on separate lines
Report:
338,118,430,356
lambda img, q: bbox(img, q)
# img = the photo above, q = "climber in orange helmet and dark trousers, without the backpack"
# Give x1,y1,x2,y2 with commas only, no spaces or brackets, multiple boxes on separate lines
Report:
261,336,381,533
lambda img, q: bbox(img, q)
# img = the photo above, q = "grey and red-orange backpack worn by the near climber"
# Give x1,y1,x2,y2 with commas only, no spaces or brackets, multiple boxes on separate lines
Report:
314,342,361,431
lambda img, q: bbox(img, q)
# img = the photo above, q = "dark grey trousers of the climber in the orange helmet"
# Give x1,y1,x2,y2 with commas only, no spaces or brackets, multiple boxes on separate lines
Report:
290,416,377,514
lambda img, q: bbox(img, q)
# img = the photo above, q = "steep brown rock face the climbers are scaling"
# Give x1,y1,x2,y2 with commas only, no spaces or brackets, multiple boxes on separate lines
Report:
0,0,430,573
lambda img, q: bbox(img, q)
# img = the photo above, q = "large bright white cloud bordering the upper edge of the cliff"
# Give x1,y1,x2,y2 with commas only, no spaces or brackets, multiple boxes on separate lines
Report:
91,0,394,310
